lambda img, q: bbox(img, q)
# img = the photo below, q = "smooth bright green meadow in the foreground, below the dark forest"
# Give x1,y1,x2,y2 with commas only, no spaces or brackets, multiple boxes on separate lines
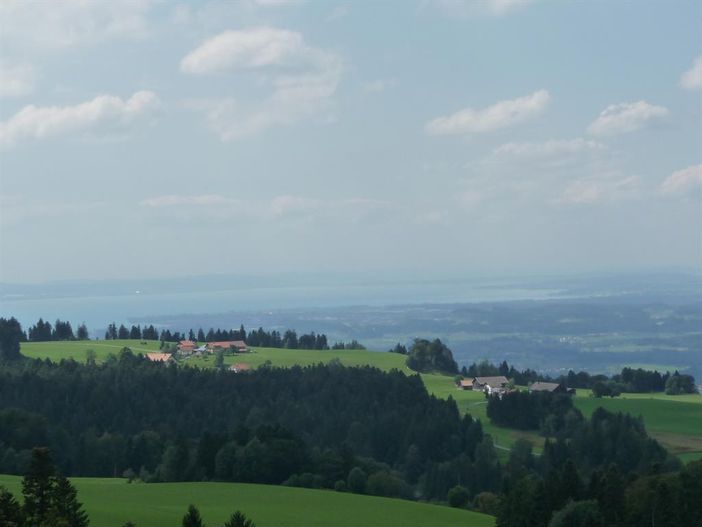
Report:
0,476,495,527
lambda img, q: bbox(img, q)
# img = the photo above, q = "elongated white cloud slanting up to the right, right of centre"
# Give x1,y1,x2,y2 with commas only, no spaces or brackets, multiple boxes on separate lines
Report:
425,90,550,135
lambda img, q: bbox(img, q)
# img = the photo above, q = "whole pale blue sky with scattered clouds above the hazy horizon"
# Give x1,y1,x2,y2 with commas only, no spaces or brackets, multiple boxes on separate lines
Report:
0,0,702,282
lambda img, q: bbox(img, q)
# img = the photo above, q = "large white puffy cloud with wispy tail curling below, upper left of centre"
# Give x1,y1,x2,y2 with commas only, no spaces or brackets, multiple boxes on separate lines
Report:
181,27,343,141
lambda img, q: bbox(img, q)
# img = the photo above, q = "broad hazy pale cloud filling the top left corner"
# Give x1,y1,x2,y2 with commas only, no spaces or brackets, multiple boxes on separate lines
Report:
0,0,155,50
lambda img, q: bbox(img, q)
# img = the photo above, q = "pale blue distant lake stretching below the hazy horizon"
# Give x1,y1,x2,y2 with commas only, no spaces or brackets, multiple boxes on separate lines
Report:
0,282,563,330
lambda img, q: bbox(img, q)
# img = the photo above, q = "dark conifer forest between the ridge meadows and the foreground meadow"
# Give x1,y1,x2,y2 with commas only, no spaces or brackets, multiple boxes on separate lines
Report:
0,352,494,497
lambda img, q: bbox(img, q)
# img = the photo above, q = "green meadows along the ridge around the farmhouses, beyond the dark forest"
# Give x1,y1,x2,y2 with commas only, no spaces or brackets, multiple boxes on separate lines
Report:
17,340,702,460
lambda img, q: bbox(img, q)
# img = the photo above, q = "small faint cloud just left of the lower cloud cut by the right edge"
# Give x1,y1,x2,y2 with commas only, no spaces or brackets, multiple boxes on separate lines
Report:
556,174,641,205
